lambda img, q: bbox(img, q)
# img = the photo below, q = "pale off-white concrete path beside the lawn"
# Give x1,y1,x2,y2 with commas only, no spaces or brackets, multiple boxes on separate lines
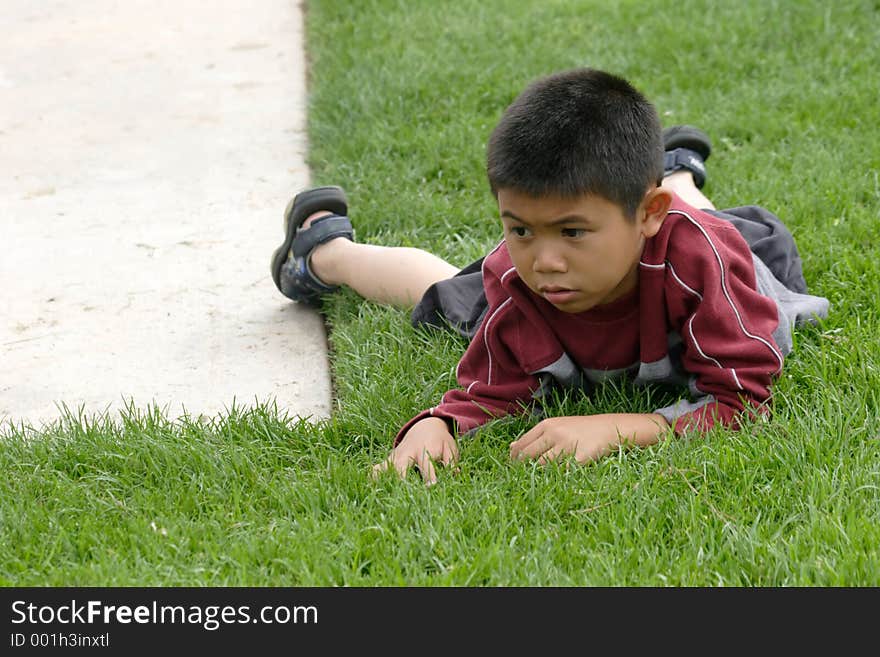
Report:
0,0,330,426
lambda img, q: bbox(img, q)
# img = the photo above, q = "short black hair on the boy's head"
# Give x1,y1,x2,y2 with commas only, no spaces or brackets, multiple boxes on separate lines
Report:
486,68,663,217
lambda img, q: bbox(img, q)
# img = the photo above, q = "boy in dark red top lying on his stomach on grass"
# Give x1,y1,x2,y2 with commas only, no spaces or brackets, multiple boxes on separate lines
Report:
272,69,828,484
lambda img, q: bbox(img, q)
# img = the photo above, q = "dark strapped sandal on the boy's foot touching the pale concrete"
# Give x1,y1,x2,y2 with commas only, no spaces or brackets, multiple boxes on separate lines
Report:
270,186,354,305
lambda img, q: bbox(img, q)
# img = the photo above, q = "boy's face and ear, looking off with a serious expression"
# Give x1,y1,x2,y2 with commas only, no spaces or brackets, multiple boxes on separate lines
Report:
498,189,668,313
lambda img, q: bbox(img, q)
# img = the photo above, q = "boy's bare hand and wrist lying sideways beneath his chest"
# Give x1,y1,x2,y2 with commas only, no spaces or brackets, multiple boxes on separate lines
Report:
510,413,669,464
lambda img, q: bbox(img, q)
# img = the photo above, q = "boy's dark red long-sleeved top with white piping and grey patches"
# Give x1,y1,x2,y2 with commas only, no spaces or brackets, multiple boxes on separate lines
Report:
394,192,783,445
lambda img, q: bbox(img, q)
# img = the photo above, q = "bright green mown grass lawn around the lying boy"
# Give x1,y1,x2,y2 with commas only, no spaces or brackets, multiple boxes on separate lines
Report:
0,0,880,586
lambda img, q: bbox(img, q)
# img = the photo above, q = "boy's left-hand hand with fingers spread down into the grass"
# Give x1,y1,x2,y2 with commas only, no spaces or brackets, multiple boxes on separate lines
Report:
372,417,458,486
